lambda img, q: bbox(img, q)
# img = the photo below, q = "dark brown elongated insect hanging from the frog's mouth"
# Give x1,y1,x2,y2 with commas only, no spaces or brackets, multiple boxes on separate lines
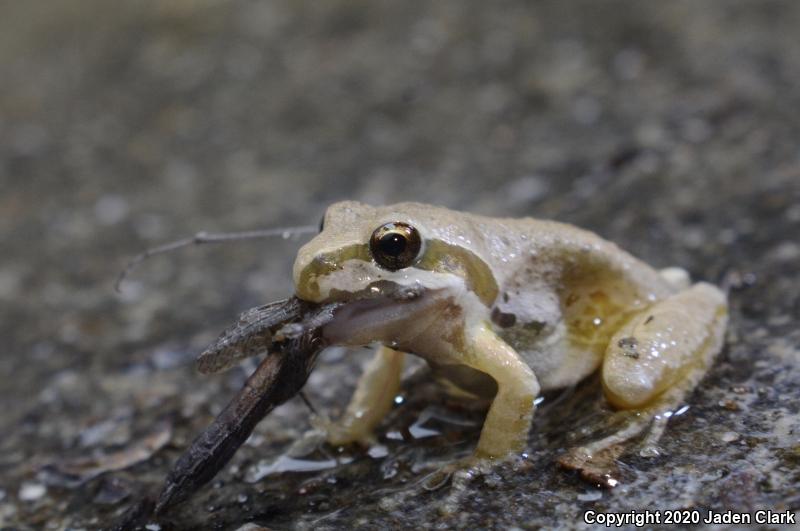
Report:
155,297,339,513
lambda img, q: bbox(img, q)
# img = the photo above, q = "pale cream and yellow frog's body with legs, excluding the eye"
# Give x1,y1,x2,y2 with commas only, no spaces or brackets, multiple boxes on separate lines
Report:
294,201,727,474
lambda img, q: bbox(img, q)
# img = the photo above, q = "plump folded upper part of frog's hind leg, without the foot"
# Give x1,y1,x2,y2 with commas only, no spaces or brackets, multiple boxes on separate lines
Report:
602,282,727,409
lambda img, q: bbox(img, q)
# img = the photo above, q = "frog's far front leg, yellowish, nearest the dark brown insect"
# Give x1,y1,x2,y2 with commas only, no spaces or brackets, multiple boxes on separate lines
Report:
327,346,404,446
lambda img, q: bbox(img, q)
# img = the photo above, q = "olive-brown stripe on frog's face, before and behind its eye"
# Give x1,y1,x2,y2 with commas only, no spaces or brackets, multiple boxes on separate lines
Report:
298,240,498,306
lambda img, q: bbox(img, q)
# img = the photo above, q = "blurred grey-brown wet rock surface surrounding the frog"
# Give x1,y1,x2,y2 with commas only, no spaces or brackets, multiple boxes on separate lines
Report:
0,0,800,529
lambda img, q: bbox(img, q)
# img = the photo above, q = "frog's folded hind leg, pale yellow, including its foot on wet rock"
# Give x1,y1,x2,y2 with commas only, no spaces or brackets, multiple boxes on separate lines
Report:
559,282,727,486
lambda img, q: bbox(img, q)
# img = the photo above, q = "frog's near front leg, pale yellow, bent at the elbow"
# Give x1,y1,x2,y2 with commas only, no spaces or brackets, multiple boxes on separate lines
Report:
460,325,539,458
